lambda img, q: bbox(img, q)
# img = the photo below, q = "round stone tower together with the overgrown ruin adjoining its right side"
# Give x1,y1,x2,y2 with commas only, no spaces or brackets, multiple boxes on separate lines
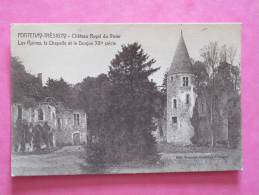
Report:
158,32,236,146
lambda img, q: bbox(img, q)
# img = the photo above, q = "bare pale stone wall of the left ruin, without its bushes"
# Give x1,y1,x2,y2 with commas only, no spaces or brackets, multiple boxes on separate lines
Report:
12,102,87,145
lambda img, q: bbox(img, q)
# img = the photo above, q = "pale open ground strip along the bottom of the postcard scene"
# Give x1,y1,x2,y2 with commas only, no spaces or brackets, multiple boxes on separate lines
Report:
12,146,240,176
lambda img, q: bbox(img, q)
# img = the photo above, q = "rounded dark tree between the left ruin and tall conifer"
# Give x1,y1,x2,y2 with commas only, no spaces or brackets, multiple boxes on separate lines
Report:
78,74,112,164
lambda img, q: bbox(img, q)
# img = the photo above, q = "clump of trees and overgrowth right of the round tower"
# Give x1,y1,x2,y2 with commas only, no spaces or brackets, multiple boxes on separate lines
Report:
192,42,241,147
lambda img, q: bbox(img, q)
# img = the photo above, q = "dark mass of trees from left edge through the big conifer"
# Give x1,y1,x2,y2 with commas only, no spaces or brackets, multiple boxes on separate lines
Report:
12,43,161,163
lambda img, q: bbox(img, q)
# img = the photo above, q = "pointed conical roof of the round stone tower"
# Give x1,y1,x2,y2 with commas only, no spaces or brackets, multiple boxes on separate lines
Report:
169,31,192,74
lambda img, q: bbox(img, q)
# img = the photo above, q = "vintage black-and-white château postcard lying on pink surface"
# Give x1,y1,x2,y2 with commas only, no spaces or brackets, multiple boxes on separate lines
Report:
11,24,242,176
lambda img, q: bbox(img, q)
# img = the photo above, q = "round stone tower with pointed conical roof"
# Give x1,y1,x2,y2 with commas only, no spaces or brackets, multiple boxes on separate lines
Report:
166,31,196,145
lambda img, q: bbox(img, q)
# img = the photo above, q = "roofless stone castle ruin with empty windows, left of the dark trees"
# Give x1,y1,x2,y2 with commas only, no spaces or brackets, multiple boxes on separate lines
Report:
12,98,87,151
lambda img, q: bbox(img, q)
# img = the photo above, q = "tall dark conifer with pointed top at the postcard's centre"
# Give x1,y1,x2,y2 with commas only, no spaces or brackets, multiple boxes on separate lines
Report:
109,43,159,161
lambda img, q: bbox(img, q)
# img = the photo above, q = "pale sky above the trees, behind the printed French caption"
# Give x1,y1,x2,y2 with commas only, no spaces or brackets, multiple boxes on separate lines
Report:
11,24,241,85
